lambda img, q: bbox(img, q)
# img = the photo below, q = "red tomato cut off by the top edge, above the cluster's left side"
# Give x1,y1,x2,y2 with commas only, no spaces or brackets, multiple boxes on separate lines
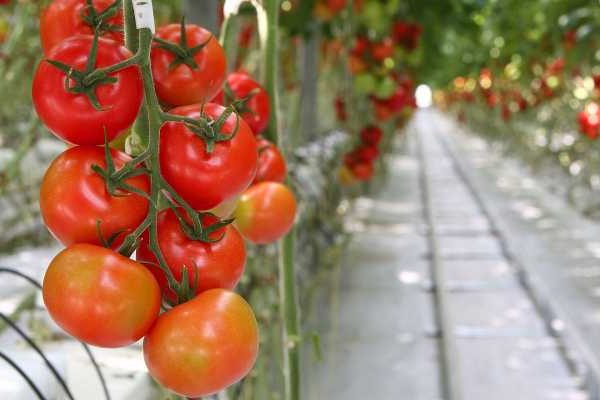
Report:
40,0,123,55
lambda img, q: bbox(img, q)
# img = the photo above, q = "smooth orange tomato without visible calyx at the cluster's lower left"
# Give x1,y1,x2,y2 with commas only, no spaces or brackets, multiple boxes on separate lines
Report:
42,244,161,347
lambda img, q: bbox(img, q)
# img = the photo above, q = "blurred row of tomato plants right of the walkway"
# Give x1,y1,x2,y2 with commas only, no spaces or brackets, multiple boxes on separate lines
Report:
436,1,600,217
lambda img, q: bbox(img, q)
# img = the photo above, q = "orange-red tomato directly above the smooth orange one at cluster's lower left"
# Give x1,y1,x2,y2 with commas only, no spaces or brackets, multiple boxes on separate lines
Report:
40,146,150,246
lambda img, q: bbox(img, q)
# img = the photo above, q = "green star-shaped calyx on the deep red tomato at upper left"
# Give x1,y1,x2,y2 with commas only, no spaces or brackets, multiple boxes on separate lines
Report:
46,33,118,111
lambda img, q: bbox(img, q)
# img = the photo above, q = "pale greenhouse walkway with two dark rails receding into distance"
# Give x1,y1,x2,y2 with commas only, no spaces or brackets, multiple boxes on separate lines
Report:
305,110,600,400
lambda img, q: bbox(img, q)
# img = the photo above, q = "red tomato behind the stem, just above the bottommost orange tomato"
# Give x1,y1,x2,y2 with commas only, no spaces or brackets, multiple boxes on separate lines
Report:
136,209,246,300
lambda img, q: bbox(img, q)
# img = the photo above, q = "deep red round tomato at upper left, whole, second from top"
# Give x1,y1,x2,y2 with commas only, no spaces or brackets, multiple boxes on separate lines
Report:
32,36,144,145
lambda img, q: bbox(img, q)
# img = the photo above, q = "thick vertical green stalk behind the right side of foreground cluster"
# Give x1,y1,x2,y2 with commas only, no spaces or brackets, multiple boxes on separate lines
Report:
256,0,301,400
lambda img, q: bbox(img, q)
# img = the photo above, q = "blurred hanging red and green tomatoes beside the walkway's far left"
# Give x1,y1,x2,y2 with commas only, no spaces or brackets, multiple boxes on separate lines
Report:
322,0,422,185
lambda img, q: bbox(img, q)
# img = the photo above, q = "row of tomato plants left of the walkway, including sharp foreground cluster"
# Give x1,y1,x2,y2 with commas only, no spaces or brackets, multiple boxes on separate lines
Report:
0,0,422,400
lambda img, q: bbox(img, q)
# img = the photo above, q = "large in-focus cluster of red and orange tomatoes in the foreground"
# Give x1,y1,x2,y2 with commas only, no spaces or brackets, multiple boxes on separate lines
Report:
32,0,296,397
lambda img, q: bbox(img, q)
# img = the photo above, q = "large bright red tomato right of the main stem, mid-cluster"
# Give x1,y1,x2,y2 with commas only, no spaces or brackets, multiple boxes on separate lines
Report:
160,103,258,210
